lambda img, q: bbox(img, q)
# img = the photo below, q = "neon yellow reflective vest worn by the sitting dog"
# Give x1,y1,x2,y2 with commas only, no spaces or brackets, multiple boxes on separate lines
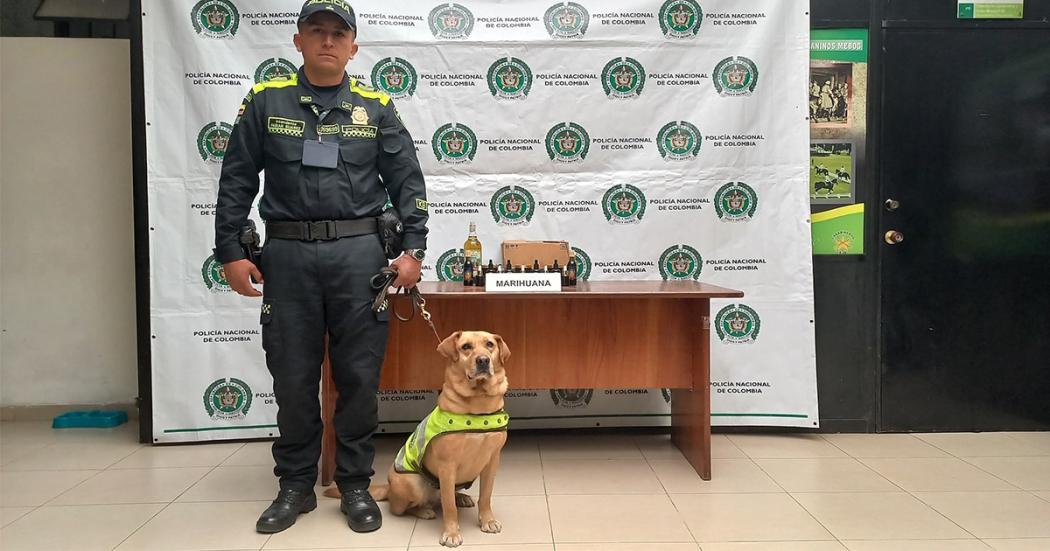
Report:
394,407,510,489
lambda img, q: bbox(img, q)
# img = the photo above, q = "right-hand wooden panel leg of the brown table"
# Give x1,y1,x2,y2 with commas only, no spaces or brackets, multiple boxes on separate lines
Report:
671,299,711,481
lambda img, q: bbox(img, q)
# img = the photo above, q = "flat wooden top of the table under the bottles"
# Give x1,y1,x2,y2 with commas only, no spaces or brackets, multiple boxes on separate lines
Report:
405,280,743,299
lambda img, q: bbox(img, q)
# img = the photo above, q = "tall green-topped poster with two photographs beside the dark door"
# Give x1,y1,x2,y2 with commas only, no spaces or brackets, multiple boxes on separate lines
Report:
809,28,870,255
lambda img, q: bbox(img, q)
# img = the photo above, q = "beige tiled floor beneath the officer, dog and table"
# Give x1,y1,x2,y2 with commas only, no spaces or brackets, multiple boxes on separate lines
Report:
0,422,1050,551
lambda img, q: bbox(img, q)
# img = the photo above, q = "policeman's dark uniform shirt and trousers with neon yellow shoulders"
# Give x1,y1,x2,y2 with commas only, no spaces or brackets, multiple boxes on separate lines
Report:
215,68,427,491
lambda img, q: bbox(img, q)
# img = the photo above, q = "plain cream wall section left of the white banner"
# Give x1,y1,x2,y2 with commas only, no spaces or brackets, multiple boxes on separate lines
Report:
0,38,138,406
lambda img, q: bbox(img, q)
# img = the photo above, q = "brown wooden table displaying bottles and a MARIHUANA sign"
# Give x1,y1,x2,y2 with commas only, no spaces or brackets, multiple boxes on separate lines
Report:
321,281,743,486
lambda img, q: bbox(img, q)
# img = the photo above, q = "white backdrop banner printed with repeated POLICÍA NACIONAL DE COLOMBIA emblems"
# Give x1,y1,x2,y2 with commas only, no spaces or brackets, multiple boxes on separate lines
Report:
143,0,818,442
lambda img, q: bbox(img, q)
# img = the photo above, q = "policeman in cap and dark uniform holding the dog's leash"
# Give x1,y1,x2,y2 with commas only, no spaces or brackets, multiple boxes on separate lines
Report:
215,0,427,533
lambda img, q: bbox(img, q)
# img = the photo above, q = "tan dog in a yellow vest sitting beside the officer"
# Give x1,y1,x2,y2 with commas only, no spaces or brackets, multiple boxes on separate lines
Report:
326,331,510,547
